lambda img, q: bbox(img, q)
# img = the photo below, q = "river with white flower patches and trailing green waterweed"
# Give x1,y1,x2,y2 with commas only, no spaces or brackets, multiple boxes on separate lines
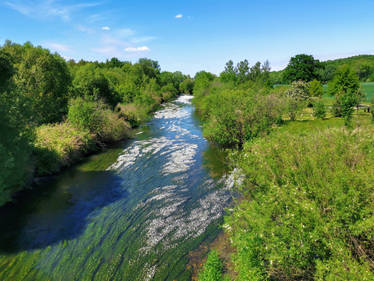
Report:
0,96,232,281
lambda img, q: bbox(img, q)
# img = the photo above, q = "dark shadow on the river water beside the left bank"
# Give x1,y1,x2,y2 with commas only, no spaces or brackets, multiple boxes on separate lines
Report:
0,170,127,254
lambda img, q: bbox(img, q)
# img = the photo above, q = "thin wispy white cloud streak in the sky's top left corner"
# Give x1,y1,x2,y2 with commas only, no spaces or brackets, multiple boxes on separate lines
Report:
5,0,100,21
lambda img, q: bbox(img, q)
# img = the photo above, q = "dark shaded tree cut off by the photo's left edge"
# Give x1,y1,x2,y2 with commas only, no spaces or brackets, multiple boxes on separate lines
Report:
0,50,32,206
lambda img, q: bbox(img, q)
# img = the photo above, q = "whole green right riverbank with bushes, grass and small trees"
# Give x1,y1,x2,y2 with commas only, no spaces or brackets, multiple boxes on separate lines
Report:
194,58,374,281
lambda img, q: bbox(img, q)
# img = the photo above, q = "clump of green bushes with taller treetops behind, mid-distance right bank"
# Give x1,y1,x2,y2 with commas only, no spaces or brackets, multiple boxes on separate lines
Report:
193,61,285,148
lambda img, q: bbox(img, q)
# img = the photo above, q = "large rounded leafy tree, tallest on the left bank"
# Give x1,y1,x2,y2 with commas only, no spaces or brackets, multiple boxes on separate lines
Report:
2,43,71,124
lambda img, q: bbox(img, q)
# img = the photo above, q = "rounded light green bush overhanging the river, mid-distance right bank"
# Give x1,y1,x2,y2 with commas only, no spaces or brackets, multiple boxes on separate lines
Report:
203,90,283,148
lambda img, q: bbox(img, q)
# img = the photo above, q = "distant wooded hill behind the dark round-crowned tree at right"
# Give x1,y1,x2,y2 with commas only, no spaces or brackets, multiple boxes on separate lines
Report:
270,55,374,84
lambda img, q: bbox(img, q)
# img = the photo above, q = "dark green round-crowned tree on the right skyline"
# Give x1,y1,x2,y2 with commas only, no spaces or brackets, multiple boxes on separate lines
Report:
283,54,320,83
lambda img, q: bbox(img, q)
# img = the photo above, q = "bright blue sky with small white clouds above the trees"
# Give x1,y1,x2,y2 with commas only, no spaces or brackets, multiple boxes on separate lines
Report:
0,0,374,75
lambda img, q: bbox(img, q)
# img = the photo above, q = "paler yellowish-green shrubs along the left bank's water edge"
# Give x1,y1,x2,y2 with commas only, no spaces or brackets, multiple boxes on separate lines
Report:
31,96,175,186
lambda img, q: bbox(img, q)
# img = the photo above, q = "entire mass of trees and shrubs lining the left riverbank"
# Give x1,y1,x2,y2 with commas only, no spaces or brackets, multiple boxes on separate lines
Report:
0,41,188,205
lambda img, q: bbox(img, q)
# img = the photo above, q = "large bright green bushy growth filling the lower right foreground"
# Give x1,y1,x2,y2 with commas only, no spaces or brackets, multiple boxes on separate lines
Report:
226,127,374,280
